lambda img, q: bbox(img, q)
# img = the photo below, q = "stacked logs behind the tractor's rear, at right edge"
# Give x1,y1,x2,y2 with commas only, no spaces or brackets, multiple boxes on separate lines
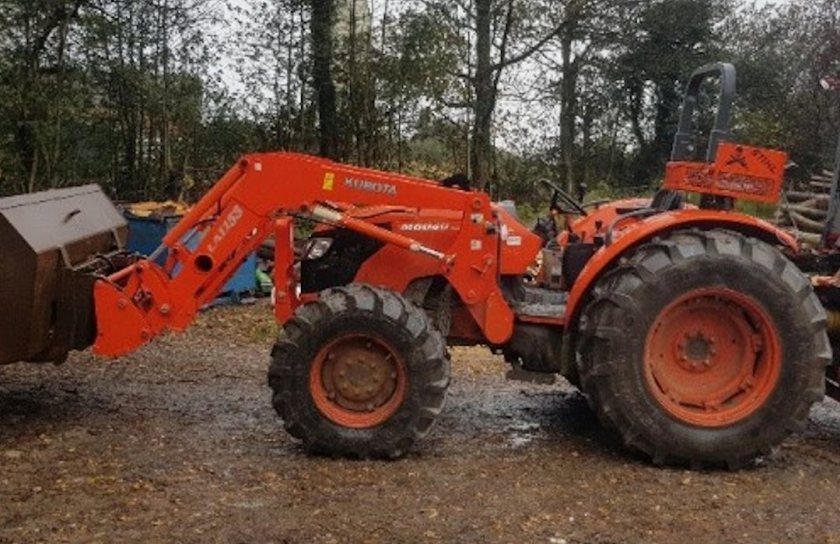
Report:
774,170,834,247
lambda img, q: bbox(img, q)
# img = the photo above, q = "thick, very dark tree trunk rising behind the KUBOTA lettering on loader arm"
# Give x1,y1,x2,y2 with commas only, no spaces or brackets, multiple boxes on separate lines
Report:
310,0,339,159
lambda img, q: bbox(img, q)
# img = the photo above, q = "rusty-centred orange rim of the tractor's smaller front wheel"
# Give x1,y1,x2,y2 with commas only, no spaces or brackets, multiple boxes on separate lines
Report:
309,334,408,429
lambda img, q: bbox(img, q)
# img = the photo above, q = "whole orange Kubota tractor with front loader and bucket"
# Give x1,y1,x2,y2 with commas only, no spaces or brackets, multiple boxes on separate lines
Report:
0,64,840,467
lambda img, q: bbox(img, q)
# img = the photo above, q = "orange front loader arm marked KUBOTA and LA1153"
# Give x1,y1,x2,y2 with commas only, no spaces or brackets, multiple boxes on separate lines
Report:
94,153,513,356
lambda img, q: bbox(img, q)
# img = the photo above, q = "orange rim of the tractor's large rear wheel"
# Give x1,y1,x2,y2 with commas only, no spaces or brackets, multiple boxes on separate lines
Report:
644,287,782,427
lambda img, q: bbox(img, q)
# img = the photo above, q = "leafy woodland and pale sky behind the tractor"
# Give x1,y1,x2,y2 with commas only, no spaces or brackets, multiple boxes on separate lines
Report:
0,0,840,214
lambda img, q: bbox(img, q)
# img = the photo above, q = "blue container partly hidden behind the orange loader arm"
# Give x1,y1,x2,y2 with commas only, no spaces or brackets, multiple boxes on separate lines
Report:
124,211,257,297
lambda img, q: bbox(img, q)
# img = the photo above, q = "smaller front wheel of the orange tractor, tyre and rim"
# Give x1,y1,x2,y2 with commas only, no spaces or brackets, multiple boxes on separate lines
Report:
268,285,450,458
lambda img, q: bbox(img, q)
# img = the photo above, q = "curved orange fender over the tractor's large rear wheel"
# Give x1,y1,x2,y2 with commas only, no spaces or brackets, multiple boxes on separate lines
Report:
565,209,799,332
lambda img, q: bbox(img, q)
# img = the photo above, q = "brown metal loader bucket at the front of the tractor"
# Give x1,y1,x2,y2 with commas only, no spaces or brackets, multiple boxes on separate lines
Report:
0,185,127,364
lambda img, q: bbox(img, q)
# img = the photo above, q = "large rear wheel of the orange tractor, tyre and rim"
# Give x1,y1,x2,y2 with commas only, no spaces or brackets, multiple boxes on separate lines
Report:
578,230,831,468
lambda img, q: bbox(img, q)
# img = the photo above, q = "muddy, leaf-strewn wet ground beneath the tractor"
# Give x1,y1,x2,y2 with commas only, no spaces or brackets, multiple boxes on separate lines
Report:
0,305,840,544
